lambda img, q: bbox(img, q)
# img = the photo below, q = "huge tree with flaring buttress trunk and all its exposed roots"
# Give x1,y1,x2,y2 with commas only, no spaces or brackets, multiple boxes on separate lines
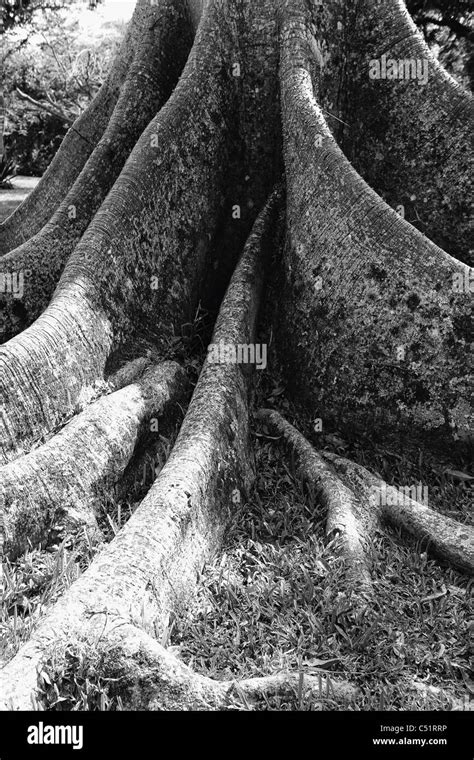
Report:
0,0,474,709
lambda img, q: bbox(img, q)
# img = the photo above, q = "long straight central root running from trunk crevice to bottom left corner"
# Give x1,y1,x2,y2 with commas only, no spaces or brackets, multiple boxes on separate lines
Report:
0,187,278,709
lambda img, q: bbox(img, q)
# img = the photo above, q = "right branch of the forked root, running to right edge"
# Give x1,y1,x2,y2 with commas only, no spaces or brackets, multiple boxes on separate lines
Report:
323,452,474,575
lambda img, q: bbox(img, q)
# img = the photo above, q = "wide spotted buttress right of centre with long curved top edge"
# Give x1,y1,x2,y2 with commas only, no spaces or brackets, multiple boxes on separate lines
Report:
276,1,472,435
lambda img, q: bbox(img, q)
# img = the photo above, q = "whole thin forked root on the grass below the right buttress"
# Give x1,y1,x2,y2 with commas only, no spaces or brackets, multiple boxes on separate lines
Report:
258,410,474,594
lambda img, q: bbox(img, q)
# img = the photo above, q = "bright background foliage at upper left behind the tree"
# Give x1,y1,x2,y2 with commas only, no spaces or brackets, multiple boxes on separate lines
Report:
2,2,121,176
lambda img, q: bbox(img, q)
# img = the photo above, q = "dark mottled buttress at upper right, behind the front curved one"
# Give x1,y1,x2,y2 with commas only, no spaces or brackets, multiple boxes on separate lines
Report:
336,0,474,266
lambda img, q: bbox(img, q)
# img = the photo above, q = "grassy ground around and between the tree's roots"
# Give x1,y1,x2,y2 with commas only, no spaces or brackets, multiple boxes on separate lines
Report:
0,412,473,710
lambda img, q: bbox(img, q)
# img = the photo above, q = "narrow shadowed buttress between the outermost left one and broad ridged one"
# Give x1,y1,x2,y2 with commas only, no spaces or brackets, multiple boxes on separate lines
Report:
0,0,192,341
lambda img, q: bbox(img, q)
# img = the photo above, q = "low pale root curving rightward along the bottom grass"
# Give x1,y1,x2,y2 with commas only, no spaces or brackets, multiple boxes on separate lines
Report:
30,622,358,711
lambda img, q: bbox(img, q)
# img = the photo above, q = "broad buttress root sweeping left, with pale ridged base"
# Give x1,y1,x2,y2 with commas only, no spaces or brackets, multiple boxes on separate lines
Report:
0,3,234,462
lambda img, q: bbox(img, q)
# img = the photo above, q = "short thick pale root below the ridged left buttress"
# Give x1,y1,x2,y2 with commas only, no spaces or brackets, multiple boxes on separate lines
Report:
0,362,186,558
